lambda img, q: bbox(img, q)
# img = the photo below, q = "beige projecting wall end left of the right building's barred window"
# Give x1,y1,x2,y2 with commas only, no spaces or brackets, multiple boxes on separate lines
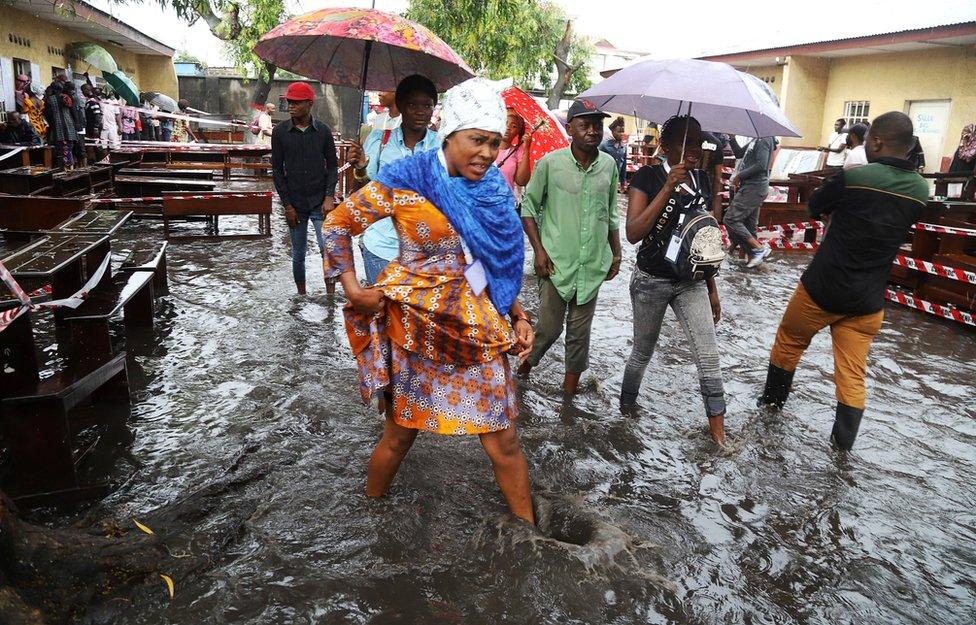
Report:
779,56,830,146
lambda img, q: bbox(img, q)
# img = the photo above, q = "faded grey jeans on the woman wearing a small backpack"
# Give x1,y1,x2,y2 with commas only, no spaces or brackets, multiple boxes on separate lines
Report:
620,267,725,417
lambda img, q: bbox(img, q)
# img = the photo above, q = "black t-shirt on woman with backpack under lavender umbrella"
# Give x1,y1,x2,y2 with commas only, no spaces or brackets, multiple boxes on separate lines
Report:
630,165,712,278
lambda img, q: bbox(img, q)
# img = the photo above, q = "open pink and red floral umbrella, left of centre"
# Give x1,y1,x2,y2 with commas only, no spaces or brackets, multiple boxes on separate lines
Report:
254,8,474,91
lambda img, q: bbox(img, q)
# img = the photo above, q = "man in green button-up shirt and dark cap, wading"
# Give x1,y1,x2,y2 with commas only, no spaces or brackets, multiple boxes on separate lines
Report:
519,100,620,395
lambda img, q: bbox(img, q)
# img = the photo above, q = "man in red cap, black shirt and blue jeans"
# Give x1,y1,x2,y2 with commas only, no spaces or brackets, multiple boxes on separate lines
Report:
271,82,339,295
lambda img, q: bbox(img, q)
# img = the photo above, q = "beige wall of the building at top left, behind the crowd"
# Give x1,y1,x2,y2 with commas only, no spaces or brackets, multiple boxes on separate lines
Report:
0,2,179,98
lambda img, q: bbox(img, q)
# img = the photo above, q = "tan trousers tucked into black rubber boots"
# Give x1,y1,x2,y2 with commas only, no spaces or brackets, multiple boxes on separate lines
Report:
769,283,884,410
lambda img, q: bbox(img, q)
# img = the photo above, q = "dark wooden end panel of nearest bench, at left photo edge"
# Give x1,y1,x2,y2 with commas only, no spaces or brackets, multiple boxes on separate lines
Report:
0,400,78,496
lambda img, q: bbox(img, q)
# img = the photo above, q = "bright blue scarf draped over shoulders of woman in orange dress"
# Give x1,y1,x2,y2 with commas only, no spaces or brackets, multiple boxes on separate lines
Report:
376,150,525,315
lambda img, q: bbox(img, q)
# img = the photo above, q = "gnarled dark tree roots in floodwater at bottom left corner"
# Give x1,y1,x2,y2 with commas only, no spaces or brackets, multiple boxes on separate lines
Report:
0,445,270,625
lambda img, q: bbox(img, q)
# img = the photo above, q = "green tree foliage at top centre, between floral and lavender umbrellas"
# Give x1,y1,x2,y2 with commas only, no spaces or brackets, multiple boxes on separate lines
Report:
406,0,593,92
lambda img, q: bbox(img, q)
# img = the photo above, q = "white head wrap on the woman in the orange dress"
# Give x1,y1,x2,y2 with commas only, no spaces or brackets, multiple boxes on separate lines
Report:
437,78,507,145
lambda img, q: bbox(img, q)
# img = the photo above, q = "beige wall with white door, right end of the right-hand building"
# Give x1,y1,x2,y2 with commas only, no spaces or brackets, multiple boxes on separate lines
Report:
824,46,976,163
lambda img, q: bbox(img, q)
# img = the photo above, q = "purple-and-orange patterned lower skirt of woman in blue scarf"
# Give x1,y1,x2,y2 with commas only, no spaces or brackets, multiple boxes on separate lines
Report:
390,343,518,434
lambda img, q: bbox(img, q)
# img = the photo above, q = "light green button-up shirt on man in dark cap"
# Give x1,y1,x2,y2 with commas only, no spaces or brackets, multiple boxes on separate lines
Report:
522,148,620,304
